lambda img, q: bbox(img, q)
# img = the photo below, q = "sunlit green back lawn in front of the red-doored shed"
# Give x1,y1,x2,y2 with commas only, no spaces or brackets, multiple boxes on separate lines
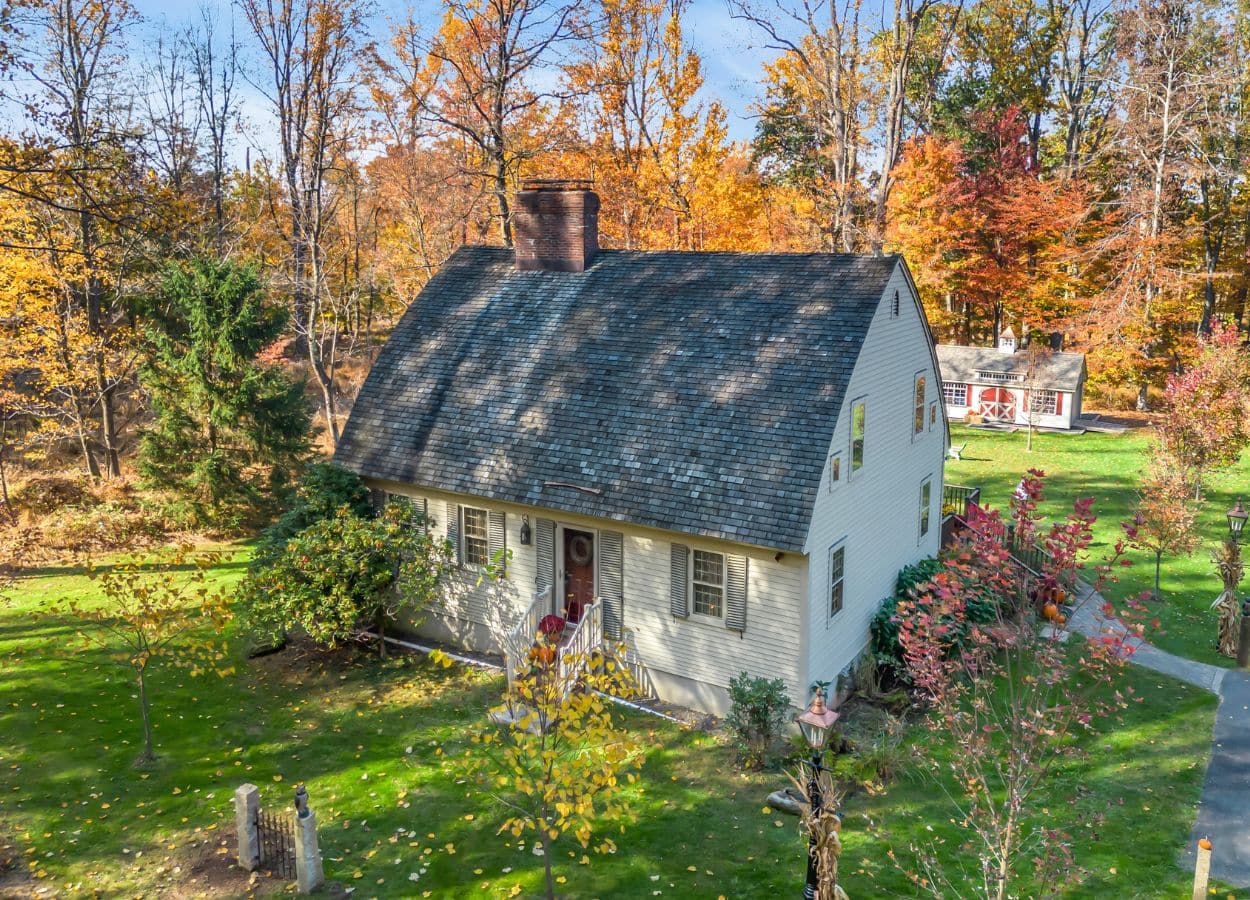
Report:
946,425,1250,666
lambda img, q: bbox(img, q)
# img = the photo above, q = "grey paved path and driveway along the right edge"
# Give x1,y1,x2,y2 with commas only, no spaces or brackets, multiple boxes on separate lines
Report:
1069,588,1250,888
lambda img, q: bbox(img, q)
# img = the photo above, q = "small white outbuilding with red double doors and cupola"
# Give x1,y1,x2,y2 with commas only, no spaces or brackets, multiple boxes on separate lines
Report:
936,329,1086,429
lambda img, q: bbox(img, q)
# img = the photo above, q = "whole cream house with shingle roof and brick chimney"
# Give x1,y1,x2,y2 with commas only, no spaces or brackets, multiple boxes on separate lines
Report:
336,183,948,714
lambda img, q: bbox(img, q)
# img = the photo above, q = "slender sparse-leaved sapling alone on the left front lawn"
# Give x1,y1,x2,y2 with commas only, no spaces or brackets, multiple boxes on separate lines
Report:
45,546,231,765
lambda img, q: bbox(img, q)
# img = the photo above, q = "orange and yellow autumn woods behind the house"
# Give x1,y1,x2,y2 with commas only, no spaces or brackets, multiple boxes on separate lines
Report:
0,0,1250,476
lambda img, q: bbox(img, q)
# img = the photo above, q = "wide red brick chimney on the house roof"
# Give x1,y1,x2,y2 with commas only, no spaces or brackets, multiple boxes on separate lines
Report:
513,179,599,271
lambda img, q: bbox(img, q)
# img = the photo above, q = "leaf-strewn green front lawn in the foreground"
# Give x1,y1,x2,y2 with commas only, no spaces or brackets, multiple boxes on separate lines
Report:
0,560,1214,899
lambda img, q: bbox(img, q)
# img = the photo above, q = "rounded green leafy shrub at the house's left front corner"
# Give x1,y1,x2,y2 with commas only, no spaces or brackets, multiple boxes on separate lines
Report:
239,500,453,656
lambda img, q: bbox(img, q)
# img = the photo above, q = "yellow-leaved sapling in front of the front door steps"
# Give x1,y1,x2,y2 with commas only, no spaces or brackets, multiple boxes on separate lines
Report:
465,650,643,900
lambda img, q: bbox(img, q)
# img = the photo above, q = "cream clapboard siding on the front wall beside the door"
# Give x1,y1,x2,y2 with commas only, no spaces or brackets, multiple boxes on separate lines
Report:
370,480,808,715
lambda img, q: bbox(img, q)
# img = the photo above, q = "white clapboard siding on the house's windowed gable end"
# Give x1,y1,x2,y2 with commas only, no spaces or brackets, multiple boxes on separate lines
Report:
805,266,946,684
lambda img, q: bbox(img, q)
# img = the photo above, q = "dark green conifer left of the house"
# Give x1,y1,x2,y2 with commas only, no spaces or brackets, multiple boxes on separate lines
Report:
139,259,309,529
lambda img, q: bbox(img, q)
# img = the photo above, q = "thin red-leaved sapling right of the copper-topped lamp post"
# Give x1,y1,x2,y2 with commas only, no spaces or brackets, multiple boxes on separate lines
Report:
898,470,1143,900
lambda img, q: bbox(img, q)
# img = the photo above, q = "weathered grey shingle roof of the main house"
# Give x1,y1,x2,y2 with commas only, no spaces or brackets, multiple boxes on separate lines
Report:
335,246,913,550
